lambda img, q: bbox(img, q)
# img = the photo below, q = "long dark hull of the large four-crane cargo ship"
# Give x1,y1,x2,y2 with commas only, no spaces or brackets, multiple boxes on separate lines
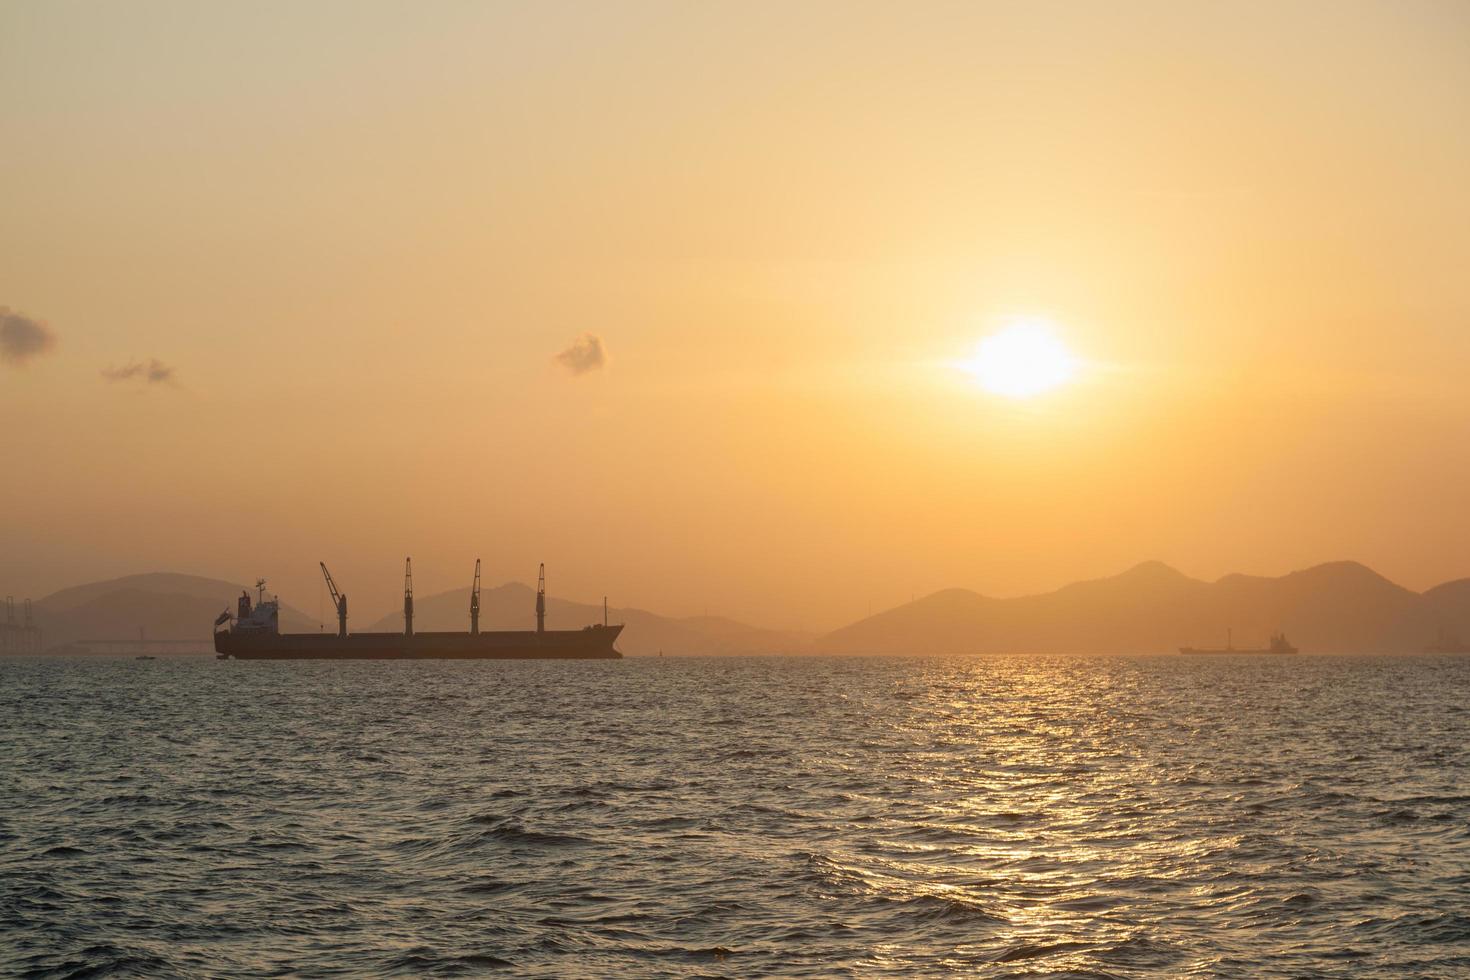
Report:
215,626,623,660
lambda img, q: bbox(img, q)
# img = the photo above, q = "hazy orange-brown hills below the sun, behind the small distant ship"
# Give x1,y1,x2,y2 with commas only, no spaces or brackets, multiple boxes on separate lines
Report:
811,561,1470,654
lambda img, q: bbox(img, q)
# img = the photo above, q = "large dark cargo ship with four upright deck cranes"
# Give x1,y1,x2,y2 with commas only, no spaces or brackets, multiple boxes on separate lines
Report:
215,560,623,660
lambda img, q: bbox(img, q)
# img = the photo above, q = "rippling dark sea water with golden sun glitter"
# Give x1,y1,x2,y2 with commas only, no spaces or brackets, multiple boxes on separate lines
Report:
0,657,1470,977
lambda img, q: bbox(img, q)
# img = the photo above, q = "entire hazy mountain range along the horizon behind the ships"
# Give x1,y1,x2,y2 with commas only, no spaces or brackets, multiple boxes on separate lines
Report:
11,561,1470,655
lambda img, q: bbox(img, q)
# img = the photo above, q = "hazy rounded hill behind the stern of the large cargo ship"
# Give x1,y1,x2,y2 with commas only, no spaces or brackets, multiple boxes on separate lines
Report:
34,572,318,648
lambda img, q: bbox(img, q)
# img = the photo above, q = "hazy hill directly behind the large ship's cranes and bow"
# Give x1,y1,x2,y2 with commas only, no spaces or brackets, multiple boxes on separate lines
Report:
354,582,811,657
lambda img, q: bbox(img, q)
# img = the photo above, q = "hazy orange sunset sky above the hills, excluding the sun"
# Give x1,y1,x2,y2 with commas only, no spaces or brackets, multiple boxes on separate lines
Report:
0,0,1470,629
